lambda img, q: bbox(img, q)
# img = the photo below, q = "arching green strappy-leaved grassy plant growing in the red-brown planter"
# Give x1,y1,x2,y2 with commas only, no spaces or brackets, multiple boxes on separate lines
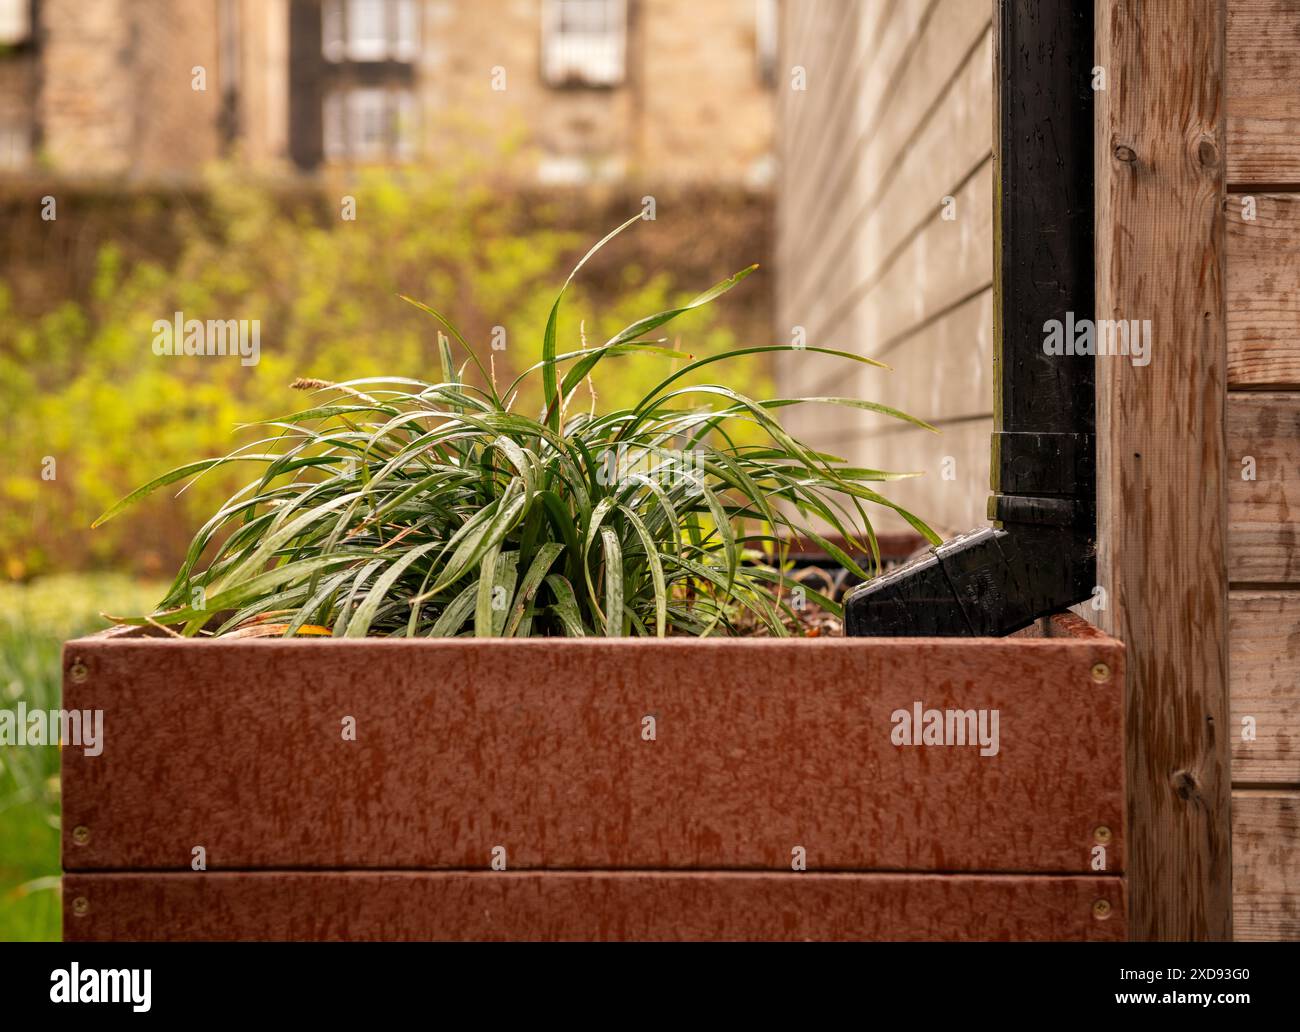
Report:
98,218,933,637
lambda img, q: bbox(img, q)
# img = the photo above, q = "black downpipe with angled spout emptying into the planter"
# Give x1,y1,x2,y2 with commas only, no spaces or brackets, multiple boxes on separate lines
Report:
844,0,1097,637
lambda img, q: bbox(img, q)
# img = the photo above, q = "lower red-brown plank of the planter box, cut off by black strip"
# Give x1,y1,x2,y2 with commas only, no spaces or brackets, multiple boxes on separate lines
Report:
64,871,1126,942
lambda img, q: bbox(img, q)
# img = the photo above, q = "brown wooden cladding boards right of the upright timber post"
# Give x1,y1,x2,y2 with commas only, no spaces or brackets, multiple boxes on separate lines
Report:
1226,0,1300,938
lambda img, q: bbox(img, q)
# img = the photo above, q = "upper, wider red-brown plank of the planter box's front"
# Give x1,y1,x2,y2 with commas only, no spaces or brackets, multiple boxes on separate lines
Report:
62,637,1125,873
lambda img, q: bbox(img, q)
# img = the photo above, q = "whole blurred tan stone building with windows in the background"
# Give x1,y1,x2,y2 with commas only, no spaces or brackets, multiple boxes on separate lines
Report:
0,0,777,187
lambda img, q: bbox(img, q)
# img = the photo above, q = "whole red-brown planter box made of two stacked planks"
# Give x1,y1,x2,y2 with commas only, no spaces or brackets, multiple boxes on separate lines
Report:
62,617,1126,940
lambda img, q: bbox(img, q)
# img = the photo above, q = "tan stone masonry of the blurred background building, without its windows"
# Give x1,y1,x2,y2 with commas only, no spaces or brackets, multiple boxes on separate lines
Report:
12,0,774,187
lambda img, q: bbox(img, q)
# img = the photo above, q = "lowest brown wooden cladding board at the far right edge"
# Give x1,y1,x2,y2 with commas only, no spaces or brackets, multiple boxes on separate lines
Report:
1232,790,1300,940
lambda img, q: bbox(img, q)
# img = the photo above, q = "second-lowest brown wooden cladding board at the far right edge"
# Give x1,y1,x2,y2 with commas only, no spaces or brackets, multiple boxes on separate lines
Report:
1229,591,1300,785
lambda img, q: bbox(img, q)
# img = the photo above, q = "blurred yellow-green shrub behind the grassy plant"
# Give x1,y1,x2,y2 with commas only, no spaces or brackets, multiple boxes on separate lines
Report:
0,168,768,578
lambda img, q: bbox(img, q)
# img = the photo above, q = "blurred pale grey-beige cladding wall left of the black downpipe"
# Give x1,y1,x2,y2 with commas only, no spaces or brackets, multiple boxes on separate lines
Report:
775,0,993,533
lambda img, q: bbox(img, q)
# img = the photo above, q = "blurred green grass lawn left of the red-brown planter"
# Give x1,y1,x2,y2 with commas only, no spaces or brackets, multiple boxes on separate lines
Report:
0,574,163,941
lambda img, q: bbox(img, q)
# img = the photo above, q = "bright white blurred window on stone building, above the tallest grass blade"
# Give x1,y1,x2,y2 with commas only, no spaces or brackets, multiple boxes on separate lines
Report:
542,0,628,86
